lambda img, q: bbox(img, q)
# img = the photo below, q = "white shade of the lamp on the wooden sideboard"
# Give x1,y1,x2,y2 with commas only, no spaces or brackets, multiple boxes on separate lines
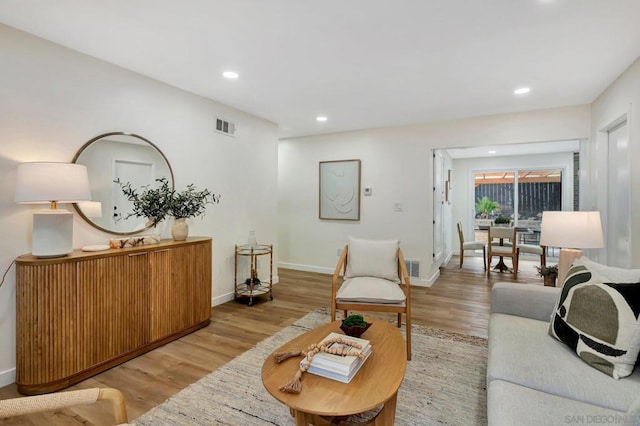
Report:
14,162,91,204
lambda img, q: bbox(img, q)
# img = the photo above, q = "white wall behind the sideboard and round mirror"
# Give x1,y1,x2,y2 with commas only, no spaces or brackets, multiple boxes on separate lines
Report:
0,25,278,386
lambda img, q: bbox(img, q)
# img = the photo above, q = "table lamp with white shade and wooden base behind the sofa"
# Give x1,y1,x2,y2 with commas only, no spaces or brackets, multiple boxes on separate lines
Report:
540,211,604,286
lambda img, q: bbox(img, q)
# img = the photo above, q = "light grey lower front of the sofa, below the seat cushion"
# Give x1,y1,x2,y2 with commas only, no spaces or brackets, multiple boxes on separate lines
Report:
487,380,625,426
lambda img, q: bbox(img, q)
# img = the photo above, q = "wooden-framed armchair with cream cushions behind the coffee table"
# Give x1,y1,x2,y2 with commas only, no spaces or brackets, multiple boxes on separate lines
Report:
331,237,411,360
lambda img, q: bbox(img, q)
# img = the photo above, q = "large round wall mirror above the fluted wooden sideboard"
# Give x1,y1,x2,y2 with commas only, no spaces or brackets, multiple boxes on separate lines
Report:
73,132,174,235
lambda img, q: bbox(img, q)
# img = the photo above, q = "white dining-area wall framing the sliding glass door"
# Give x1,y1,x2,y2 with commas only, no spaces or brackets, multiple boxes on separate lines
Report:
451,152,573,253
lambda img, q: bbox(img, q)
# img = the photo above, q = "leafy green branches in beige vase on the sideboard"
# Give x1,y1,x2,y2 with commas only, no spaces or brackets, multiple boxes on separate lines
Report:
169,184,220,241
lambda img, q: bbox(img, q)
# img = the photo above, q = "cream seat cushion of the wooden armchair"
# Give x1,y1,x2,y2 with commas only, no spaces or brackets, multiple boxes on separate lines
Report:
336,277,406,305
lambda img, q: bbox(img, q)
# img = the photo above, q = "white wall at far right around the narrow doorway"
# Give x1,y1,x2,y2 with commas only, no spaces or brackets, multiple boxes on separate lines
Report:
585,58,640,268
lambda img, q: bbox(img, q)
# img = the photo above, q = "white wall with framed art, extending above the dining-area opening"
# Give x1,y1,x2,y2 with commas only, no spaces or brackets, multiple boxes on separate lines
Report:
278,105,590,281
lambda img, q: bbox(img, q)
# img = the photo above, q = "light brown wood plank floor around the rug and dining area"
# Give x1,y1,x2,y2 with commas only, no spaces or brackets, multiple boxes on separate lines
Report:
0,257,542,425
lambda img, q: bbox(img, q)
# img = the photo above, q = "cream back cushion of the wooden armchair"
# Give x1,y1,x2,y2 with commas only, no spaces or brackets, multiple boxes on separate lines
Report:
346,237,400,282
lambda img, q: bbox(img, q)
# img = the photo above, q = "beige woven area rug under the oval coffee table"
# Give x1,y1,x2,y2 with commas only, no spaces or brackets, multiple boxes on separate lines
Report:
133,309,487,426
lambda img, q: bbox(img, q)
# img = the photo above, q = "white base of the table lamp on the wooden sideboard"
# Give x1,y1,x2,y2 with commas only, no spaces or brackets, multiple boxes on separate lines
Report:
31,210,73,257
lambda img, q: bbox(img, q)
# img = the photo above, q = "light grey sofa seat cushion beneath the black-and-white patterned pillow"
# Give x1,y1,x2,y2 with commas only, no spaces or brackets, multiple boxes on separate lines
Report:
487,314,640,411
